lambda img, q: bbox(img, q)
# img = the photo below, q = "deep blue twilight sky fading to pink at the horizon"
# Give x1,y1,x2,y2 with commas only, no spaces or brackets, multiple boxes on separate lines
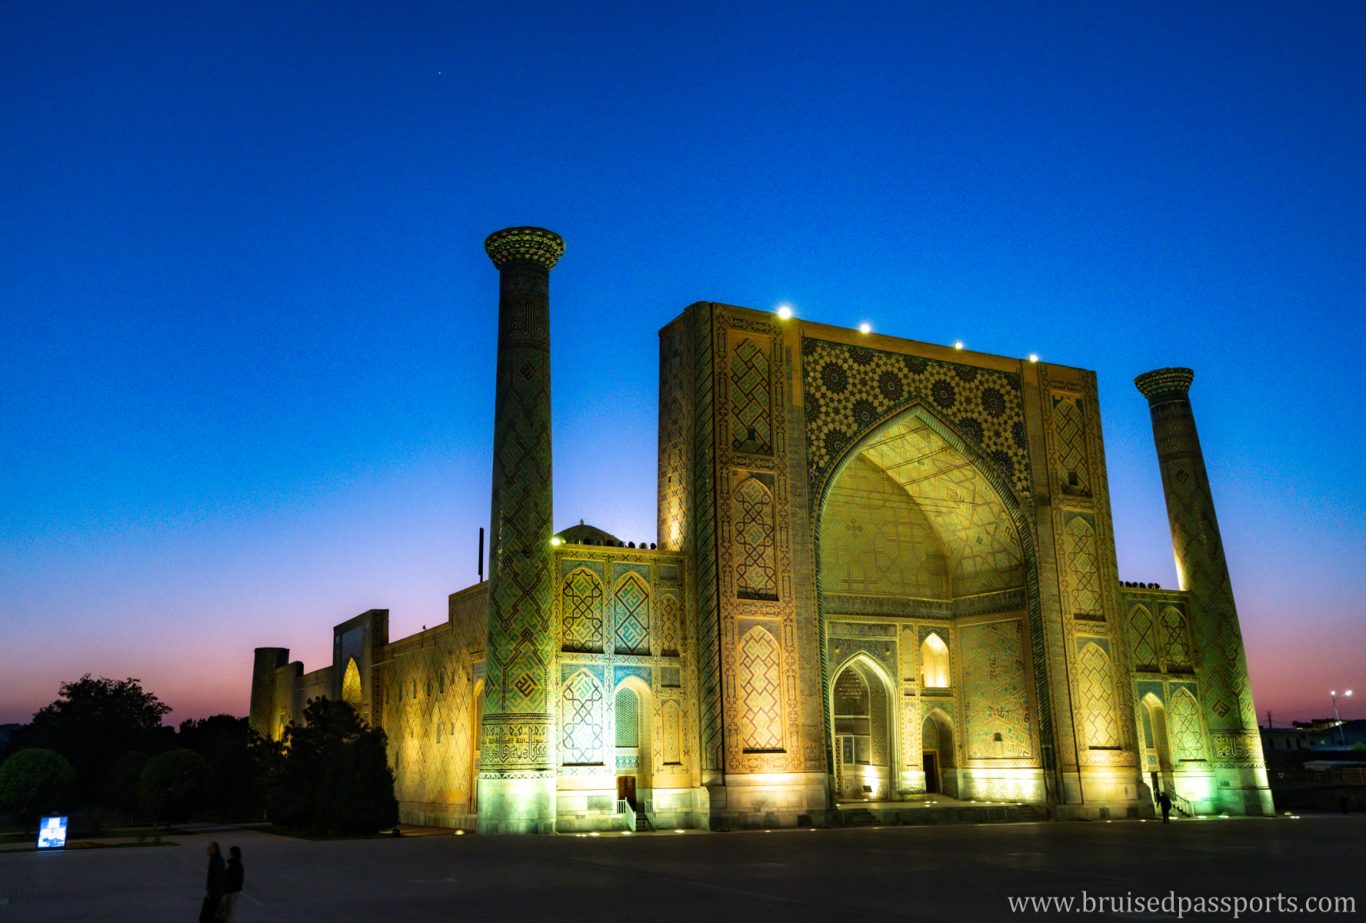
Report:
0,1,1366,724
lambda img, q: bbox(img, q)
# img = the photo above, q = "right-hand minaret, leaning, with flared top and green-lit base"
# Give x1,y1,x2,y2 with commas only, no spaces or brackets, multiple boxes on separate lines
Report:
1134,369,1273,814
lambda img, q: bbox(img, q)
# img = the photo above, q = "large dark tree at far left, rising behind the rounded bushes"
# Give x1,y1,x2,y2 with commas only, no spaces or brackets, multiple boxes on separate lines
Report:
12,673,172,804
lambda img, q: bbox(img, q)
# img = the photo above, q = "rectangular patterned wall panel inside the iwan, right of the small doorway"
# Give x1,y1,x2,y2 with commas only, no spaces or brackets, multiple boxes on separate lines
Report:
959,620,1033,759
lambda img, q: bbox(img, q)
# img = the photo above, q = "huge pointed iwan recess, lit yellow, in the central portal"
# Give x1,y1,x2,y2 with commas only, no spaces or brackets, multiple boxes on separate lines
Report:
816,406,1046,801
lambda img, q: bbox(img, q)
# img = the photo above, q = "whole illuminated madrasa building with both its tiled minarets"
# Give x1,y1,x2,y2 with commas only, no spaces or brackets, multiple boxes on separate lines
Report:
251,228,1273,833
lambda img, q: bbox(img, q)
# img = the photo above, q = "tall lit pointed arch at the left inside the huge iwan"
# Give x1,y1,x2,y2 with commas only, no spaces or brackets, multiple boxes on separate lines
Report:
831,655,896,801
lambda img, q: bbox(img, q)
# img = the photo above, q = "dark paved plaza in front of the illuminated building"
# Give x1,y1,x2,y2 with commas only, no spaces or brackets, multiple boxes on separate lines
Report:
0,815,1366,923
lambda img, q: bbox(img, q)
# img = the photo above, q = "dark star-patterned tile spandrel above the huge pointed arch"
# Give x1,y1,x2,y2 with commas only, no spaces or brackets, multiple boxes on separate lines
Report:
802,337,1029,496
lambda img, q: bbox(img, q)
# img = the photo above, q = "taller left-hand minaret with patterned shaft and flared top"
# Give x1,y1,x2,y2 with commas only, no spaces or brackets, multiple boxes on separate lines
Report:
478,228,564,833
